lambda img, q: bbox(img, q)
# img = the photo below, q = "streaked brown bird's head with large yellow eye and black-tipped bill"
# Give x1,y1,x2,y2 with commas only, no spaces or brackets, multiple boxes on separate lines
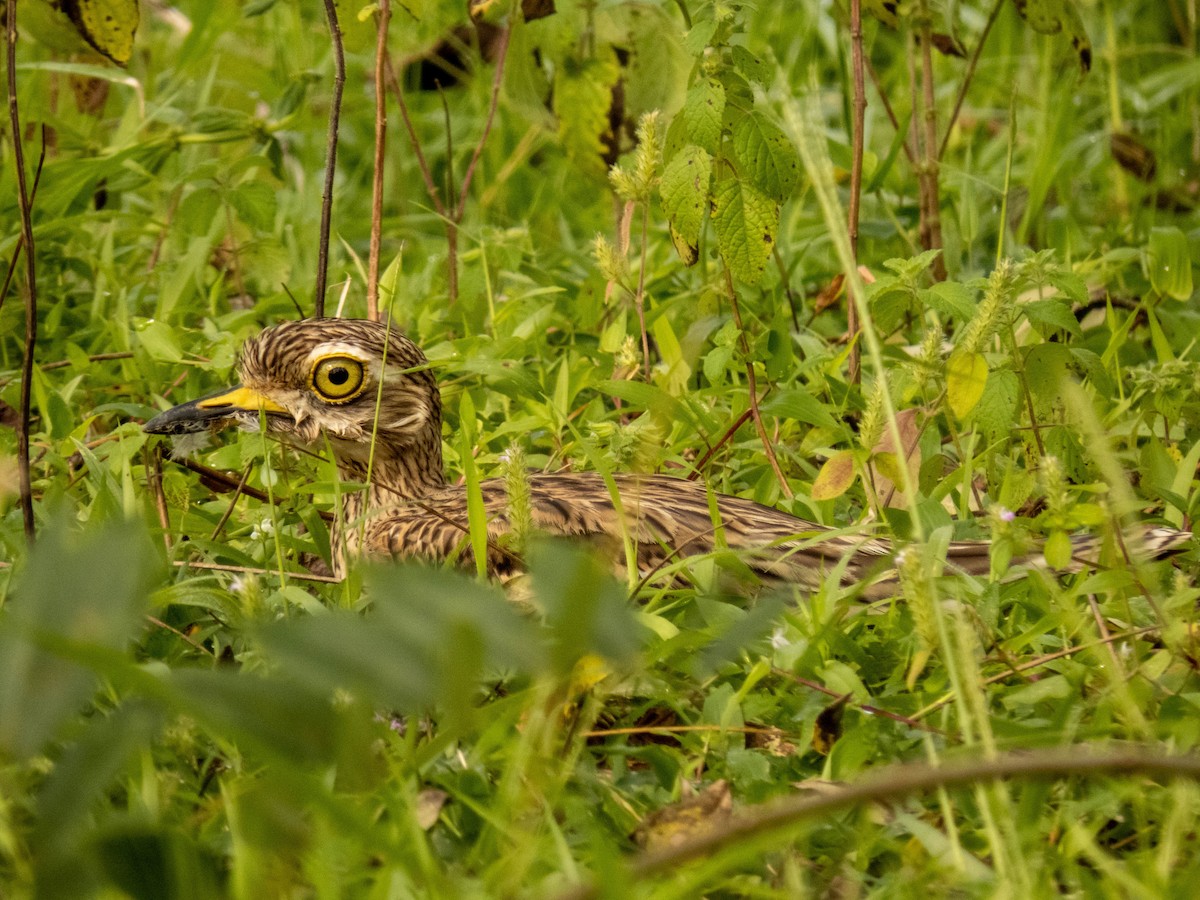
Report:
144,319,442,468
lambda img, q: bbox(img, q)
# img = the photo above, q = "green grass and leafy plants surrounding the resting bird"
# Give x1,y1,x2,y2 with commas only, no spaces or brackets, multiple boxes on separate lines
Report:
0,0,1200,898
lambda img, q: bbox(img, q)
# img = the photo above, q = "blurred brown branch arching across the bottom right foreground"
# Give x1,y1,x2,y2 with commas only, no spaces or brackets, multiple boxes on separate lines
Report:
557,746,1200,900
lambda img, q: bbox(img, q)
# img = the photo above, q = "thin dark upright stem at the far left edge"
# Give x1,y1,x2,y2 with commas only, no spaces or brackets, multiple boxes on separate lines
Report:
6,0,37,545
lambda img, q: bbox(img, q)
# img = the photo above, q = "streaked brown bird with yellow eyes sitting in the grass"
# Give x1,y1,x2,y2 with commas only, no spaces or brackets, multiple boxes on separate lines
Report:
143,318,1192,599
